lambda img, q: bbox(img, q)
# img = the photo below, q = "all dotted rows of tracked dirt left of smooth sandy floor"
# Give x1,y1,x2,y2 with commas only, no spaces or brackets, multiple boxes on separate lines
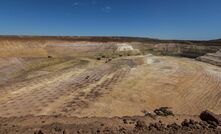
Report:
0,58,135,117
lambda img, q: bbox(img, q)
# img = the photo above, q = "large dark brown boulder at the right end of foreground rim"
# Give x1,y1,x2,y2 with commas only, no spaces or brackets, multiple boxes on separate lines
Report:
200,110,221,125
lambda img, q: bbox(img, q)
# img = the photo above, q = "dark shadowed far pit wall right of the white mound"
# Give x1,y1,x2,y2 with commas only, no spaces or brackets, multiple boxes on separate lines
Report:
134,43,221,58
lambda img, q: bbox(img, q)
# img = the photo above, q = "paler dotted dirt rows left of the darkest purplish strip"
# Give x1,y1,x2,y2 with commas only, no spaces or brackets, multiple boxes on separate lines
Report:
0,58,91,116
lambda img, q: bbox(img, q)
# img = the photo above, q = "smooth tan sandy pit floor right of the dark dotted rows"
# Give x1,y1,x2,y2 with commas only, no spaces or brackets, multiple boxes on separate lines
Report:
77,57,221,117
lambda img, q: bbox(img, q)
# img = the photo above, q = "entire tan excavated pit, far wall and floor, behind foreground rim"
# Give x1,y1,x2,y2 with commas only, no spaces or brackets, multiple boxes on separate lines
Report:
0,37,221,117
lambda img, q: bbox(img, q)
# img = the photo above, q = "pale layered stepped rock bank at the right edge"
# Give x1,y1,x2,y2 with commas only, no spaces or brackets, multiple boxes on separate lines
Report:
197,50,221,66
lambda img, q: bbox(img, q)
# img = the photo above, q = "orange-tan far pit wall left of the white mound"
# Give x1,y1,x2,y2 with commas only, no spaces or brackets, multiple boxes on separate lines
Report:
0,40,116,58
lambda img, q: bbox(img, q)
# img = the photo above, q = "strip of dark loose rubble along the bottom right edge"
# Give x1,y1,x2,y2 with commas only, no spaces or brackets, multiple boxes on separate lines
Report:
134,119,221,134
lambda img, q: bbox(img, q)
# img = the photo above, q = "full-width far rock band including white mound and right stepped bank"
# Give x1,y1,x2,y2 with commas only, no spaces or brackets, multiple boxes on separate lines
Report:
0,36,221,66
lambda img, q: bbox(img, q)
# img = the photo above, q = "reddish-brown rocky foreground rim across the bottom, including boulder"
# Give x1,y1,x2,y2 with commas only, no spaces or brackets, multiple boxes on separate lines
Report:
0,111,221,134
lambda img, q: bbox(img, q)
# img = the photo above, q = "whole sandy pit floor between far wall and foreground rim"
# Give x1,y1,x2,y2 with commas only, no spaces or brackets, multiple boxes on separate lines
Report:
0,56,221,117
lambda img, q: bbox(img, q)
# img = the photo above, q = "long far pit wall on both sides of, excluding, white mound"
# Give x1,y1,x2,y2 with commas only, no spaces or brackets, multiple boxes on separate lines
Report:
0,39,221,58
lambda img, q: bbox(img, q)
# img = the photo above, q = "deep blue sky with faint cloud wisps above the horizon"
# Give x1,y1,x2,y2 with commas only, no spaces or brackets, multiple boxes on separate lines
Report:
0,0,221,40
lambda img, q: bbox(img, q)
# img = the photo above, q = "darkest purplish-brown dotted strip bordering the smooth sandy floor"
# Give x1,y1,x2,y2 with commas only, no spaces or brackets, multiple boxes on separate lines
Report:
57,68,129,116
